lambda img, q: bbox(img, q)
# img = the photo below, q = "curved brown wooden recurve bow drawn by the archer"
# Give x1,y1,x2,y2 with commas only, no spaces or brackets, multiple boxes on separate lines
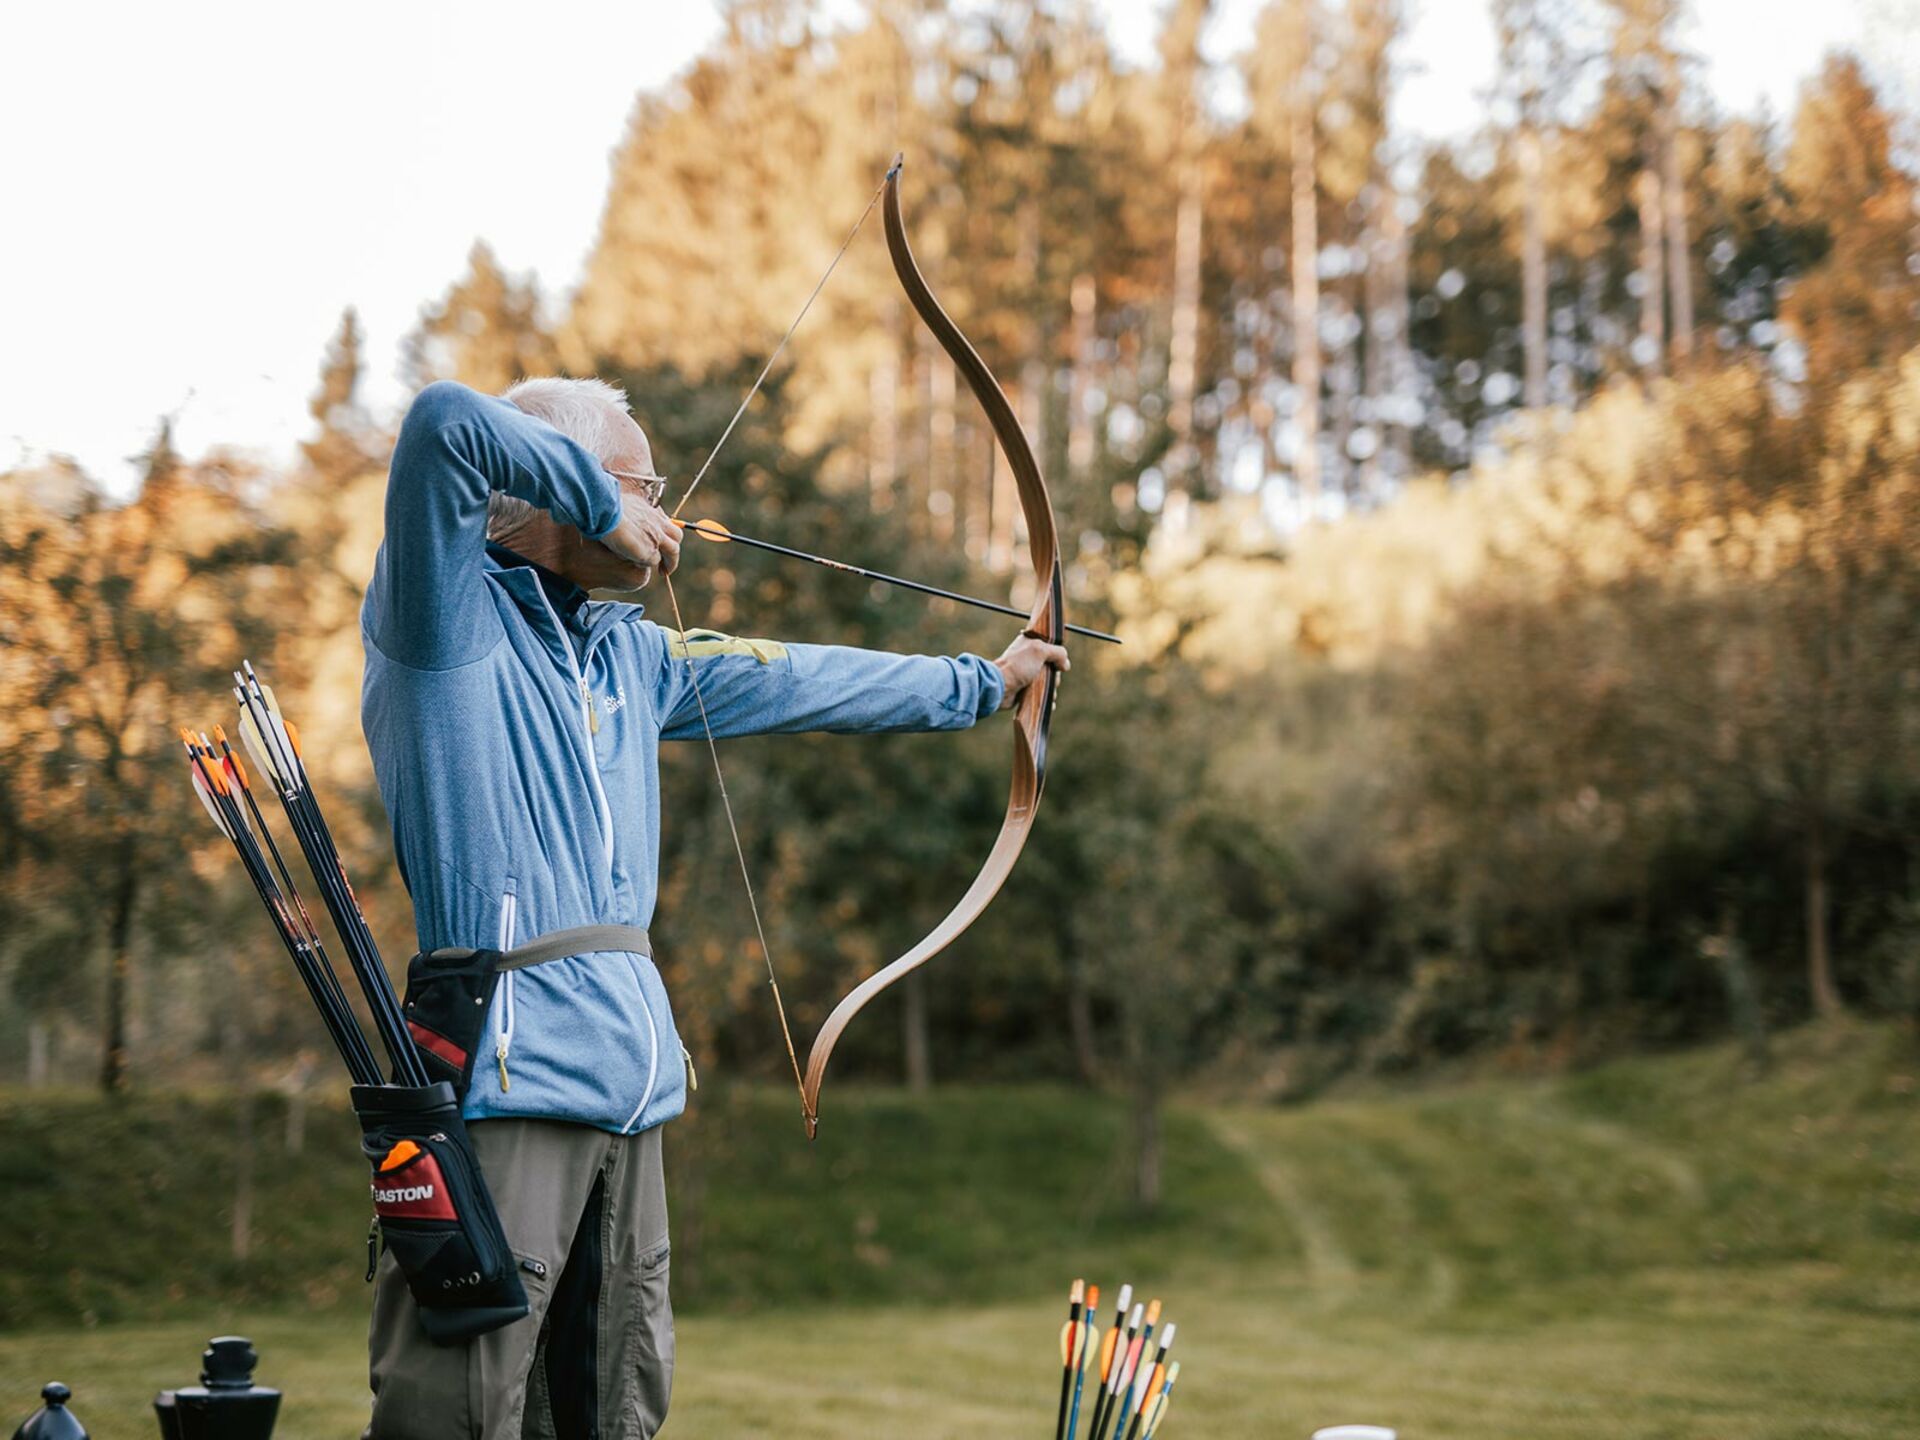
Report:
801,159,1066,1139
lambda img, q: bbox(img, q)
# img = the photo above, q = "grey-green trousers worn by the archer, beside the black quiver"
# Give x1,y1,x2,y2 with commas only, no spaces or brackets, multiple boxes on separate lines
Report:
367,1119,674,1440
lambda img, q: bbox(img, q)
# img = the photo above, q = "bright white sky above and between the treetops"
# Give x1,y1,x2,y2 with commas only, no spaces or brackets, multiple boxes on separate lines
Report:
0,0,1903,488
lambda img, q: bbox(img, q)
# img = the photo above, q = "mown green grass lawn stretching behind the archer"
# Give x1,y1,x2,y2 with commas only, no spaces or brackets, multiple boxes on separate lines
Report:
0,1025,1920,1440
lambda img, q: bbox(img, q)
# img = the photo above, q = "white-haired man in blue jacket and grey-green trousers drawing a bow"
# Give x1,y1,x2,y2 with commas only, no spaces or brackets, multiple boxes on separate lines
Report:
361,380,1068,1440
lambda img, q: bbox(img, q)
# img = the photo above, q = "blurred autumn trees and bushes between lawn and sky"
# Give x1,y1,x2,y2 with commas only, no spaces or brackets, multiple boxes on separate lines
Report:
0,0,1920,1185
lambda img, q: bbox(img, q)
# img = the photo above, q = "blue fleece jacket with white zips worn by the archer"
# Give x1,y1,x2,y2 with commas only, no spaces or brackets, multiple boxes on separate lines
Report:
361,382,1002,1133
